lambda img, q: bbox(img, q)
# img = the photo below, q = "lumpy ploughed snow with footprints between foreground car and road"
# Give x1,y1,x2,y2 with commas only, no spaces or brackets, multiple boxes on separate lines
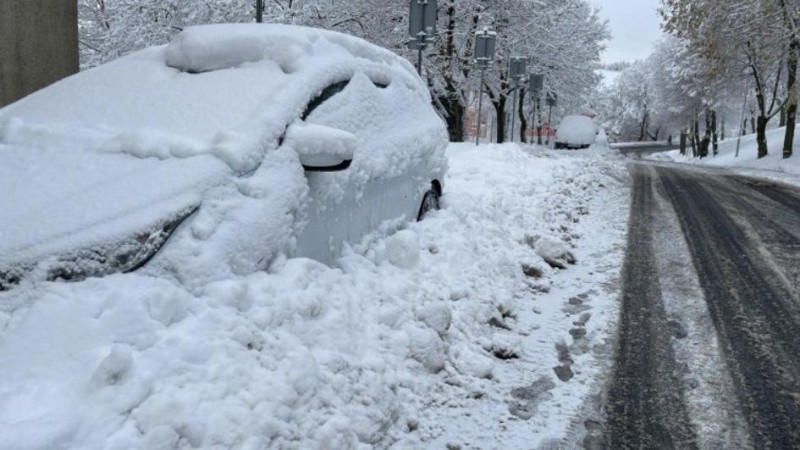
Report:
0,144,628,449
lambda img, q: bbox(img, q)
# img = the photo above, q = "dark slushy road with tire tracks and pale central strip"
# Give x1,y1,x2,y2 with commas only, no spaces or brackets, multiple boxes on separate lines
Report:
604,164,800,449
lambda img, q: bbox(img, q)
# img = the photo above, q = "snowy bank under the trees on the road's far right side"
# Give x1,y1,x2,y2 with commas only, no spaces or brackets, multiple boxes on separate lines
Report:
650,128,800,184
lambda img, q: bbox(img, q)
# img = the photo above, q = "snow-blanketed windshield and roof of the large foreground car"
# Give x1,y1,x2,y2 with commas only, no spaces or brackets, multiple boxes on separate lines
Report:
0,24,428,172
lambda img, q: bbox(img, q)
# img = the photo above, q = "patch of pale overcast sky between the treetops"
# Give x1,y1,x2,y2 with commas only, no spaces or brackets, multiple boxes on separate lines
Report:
592,0,661,63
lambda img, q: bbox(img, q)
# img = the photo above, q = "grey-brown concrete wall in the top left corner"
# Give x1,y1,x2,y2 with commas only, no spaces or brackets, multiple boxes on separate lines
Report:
0,0,78,107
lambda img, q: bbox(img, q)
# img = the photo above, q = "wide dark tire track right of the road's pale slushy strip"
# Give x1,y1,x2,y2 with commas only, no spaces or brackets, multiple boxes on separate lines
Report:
658,168,800,449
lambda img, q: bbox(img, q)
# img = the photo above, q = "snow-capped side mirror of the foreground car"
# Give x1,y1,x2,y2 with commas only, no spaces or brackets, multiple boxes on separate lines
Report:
284,123,358,172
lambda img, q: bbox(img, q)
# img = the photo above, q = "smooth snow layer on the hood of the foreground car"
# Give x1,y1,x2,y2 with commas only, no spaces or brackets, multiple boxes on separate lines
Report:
0,145,231,266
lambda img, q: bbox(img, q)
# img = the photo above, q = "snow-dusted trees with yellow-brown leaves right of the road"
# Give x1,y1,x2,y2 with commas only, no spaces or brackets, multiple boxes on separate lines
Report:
661,0,798,158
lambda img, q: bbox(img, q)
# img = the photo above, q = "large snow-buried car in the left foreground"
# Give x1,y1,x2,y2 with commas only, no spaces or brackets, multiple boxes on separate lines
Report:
0,24,447,290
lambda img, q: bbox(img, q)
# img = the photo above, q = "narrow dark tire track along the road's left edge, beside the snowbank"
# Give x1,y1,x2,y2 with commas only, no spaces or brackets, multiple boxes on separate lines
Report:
604,166,697,449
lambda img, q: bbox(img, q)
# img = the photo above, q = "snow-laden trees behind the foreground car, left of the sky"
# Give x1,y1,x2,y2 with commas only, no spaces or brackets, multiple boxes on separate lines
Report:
78,0,608,141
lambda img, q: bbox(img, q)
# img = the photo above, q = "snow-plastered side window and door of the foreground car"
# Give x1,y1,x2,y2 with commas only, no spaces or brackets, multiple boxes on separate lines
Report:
296,73,419,264
